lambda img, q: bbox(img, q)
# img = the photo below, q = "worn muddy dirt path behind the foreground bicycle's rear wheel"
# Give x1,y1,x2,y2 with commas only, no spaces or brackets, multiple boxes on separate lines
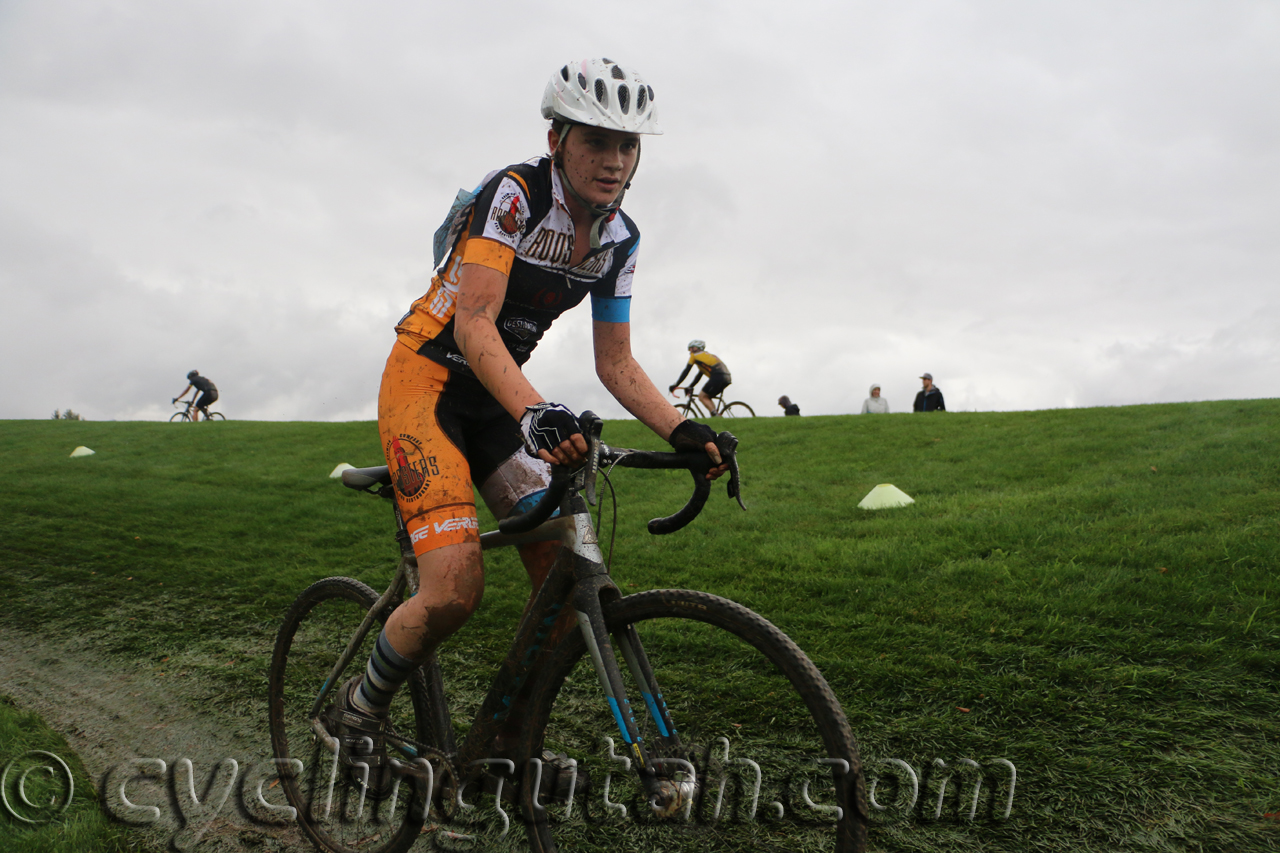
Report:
0,626,314,853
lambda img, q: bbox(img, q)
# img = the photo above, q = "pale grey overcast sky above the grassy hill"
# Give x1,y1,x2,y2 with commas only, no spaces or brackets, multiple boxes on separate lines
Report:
0,0,1280,420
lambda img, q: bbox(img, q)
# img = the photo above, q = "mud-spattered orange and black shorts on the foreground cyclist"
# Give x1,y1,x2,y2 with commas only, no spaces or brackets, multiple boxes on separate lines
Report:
378,341,550,555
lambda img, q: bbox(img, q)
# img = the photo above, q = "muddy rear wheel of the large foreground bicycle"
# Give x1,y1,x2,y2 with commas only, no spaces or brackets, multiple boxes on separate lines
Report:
269,578,440,853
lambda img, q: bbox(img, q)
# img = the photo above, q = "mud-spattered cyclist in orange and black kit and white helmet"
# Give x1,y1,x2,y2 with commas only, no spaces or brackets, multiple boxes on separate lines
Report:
334,59,727,797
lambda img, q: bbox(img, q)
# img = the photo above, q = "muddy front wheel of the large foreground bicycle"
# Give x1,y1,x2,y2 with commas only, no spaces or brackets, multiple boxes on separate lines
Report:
521,589,868,853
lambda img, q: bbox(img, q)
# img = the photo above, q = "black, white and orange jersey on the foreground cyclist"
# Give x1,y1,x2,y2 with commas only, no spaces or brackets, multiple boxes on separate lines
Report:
396,158,640,374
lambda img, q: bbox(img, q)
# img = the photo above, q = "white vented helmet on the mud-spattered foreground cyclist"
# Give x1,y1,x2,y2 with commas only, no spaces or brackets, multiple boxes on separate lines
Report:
543,59,662,136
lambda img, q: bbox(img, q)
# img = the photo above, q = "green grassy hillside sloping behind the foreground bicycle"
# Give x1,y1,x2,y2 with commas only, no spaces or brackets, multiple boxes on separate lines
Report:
0,401,1280,852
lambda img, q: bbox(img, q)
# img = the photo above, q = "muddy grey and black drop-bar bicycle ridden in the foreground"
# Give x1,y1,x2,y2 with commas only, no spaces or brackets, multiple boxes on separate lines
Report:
269,412,868,853
